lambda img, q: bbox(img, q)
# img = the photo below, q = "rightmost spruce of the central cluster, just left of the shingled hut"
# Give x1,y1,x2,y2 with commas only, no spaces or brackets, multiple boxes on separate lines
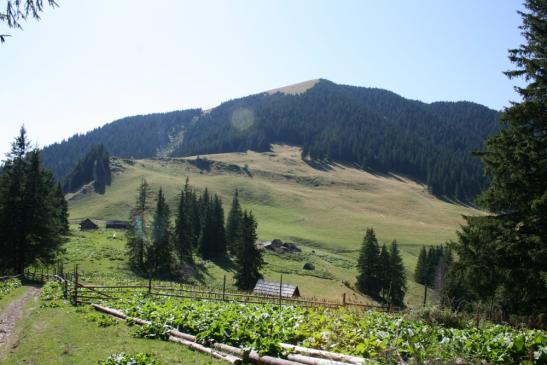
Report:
235,211,264,290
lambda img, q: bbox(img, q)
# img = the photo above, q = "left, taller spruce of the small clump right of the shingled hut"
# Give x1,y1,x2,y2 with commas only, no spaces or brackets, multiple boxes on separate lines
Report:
357,228,381,298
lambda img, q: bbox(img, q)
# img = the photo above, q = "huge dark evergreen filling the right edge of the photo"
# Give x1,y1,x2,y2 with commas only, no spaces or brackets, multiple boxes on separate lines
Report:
451,0,547,314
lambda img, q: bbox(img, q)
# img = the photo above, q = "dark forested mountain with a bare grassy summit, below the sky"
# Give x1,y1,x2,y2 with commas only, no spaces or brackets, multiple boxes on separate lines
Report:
44,79,499,201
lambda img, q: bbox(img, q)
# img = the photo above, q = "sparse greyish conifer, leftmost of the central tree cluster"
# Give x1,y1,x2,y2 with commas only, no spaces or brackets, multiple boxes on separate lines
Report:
126,179,151,272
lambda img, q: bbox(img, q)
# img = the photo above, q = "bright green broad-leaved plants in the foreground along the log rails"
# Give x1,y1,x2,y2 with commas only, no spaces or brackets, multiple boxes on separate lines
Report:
99,297,547,364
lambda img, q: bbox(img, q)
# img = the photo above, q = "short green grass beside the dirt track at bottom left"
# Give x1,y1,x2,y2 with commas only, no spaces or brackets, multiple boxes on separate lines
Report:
2,288,225,365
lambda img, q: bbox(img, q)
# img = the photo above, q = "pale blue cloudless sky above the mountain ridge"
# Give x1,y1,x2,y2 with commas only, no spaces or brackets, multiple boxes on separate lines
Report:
0,0,523,158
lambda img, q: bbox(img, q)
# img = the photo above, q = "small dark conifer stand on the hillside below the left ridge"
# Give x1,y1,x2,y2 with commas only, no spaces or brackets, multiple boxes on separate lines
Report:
63,144,112,194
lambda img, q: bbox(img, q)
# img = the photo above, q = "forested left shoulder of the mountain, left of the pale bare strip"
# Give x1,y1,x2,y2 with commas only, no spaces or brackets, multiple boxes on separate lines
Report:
41,109,201,180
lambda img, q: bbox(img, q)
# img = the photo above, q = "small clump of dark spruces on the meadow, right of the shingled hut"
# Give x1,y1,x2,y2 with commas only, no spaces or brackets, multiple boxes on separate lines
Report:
357,228,407,307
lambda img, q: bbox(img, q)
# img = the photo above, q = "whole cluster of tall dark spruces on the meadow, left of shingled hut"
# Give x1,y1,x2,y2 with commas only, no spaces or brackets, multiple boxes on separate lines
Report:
127,179,263,290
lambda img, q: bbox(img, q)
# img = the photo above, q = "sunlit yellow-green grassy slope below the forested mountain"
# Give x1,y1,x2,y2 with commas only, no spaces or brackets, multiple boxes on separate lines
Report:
66,146,479,304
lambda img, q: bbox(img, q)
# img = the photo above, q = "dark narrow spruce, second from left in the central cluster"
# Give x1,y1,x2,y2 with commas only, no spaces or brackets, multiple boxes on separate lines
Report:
148,188,172,276
